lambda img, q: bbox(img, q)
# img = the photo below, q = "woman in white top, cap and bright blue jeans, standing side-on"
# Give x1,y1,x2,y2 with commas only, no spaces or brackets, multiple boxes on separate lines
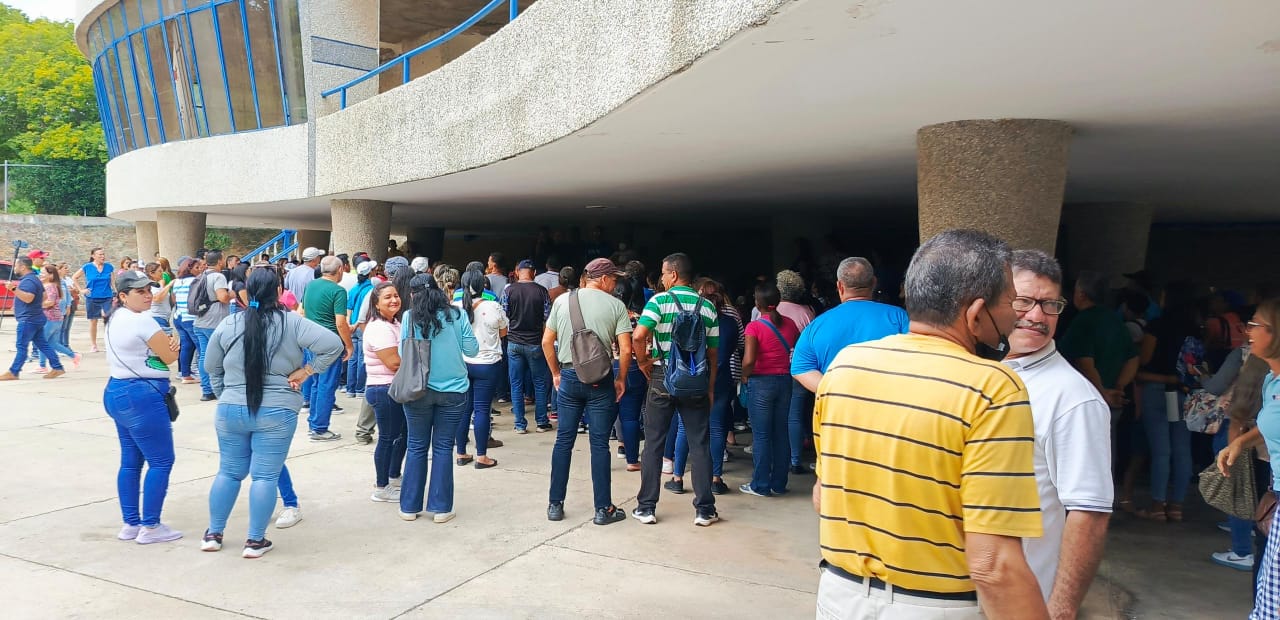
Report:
102,272,182,544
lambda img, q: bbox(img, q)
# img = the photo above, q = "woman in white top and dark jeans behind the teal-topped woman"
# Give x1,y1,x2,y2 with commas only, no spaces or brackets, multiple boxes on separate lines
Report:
456,270,509,469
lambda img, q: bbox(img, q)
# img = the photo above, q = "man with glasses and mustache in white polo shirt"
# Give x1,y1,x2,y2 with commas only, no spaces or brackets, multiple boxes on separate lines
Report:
1005,250,1114,619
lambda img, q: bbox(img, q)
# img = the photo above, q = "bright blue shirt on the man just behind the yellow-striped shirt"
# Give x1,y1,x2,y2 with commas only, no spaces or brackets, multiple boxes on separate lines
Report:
791,300,910,375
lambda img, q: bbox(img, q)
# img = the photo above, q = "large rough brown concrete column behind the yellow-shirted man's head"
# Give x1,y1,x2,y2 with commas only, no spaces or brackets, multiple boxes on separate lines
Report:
916,119,1071,254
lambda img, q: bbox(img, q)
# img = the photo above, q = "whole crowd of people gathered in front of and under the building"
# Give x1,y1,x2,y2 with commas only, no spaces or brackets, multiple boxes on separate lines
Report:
0,231,1280,619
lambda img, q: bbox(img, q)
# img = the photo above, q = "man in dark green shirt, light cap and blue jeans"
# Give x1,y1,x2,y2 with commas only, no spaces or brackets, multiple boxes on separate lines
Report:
294,256,352,442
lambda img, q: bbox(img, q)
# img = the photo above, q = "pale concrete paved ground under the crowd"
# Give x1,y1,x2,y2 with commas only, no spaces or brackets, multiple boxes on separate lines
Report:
0,318,1251,619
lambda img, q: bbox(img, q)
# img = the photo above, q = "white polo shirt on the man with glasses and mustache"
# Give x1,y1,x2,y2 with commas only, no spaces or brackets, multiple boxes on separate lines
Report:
1005,341,1115,601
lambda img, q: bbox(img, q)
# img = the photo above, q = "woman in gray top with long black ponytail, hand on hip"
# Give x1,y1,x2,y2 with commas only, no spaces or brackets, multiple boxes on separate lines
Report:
201,269,343,559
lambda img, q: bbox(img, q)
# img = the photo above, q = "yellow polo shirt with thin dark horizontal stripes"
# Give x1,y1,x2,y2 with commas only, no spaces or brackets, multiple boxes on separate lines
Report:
814,334,1041,593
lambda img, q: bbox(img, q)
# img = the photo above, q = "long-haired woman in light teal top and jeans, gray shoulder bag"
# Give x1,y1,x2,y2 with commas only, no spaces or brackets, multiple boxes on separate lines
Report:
399,274,480,523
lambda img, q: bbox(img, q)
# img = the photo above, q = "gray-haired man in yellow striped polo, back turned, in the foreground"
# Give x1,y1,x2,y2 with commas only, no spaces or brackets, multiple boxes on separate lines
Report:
813,231,1047,620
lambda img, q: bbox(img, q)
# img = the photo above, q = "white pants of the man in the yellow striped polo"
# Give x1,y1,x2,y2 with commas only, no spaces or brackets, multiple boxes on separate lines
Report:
817,570,986,620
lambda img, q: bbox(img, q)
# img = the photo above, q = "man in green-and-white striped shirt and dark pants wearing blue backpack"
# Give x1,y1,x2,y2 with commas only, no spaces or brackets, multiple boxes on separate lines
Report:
631,254,719,525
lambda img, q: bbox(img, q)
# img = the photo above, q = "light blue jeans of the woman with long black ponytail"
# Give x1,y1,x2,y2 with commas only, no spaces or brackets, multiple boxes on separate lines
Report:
209,404,298,541
